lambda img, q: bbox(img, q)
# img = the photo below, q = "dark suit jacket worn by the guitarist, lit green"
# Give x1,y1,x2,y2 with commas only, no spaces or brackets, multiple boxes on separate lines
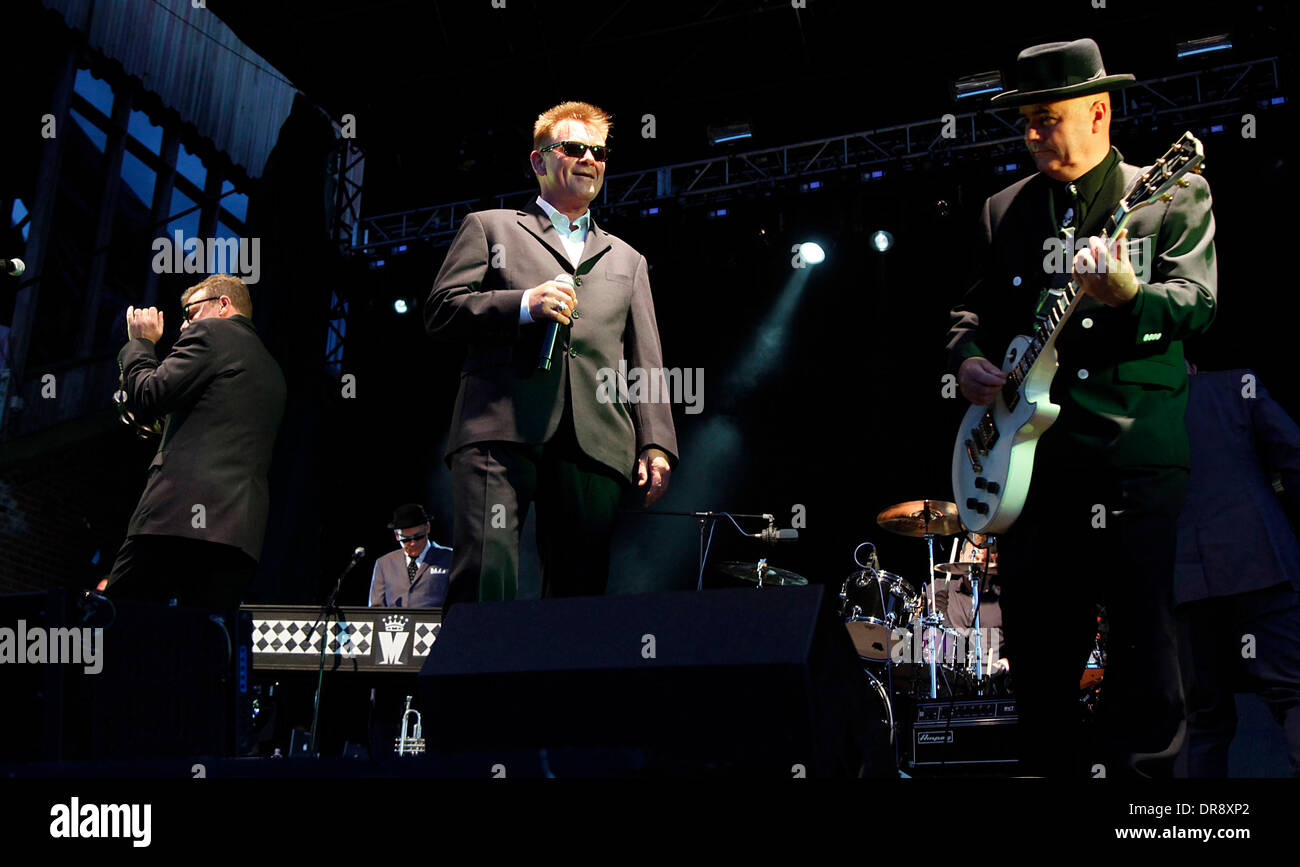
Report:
948,152,1218,467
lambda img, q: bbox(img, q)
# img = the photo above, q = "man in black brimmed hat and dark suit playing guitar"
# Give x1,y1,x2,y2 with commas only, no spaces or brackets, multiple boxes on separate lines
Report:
948,39,1217,776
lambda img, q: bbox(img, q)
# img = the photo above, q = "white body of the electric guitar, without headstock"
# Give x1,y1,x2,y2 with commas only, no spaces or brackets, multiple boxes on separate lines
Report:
953,337,1061,534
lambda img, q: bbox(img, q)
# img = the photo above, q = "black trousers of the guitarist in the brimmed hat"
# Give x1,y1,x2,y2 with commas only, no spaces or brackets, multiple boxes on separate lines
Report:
998,468,1187,777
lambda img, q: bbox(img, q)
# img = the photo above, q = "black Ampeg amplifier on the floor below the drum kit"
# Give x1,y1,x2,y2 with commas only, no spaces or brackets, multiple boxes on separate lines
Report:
911,698,1018,767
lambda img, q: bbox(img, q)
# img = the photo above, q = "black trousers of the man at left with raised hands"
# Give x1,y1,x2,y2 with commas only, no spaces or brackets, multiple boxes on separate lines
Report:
105,536,257,608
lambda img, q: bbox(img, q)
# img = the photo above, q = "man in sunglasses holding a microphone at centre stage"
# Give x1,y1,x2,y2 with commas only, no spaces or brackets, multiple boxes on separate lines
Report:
425,103,677,606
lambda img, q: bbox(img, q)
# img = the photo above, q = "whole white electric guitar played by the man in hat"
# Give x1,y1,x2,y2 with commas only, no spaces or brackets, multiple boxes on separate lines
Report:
953,133,1205,533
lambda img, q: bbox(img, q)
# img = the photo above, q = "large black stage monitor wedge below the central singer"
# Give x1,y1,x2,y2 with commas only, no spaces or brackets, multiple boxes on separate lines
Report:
420,586,880,777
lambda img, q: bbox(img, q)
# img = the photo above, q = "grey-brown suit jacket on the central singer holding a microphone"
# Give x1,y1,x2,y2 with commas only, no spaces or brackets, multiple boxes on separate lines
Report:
425,201,677,481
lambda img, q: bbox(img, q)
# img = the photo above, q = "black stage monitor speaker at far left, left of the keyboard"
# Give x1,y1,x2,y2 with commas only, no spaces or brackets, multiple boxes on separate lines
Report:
0,590,252,762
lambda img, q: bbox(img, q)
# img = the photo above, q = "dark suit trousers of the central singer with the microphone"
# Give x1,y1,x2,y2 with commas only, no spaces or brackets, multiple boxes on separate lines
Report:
445,413,627,610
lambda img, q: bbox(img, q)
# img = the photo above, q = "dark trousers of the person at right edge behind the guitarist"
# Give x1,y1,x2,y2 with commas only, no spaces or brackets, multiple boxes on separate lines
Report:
1178,584,1300,777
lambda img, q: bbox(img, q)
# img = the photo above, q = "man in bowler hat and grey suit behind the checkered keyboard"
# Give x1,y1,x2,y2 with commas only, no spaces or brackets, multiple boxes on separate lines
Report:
371,503,451,608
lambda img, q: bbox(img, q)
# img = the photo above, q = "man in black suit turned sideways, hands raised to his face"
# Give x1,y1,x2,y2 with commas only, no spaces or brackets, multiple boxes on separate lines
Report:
107,274,286,608
